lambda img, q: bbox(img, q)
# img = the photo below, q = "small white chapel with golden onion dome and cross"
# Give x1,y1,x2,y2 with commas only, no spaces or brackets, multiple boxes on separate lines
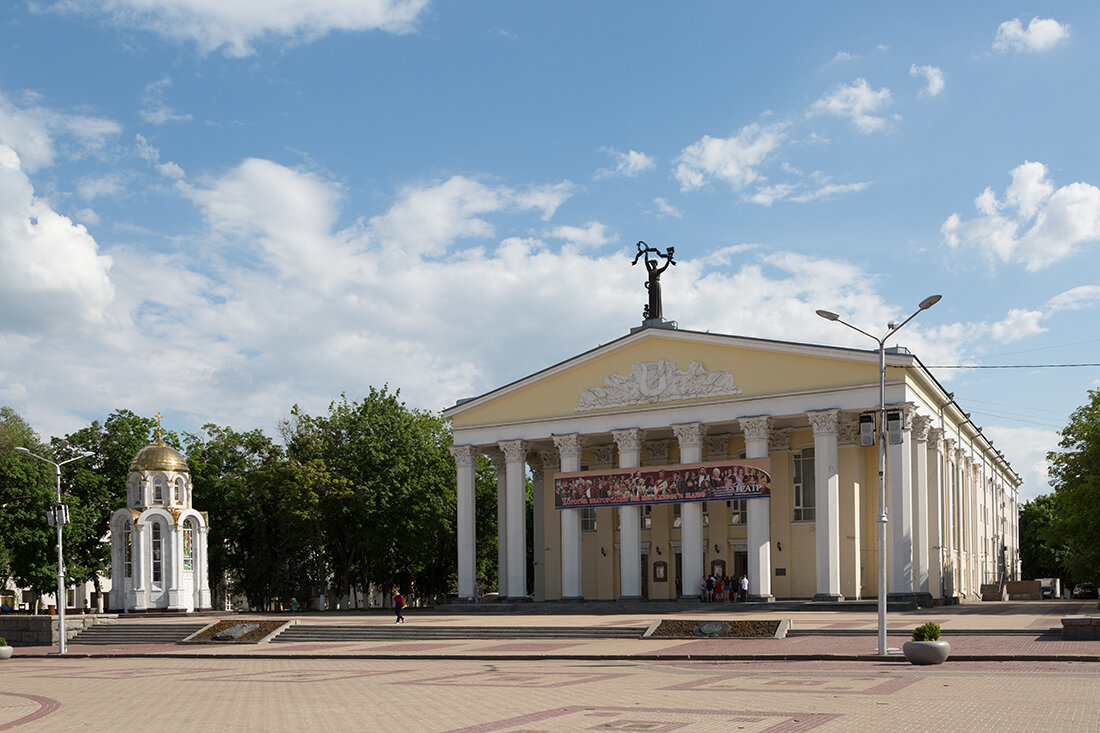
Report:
111,413,210,611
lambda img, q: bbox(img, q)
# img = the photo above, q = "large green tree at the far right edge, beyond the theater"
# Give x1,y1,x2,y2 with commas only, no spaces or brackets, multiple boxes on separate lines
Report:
1047,390,1100,583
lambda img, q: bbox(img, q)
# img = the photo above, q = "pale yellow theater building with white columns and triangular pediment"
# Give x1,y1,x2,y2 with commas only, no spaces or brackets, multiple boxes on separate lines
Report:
443,321,1021,603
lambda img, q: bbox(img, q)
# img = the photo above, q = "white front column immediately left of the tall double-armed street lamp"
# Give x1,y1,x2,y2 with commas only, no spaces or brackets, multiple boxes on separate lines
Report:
806,409,844,601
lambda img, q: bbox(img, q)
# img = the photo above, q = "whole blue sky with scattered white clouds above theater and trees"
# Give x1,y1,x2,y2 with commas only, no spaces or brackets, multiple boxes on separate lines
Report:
0,0,1100,497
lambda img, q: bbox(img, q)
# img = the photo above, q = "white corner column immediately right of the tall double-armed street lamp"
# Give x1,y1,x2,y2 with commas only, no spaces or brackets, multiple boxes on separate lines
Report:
887,403,913,597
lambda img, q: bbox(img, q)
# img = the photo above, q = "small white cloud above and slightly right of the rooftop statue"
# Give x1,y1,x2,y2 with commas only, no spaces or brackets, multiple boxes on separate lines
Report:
675,123,783,190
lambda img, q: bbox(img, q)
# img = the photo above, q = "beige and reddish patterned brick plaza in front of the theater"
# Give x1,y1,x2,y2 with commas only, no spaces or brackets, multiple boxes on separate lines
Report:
0,602,1100,733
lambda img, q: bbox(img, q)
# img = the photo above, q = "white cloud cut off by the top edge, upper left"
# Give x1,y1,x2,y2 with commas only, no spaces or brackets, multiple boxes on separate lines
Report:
56,0,428,56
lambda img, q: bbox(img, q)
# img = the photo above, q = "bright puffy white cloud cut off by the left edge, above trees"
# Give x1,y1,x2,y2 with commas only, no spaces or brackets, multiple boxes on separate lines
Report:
0,145,114,333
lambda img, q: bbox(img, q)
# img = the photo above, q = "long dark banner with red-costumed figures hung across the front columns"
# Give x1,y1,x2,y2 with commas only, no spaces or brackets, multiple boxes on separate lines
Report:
553,458,771,508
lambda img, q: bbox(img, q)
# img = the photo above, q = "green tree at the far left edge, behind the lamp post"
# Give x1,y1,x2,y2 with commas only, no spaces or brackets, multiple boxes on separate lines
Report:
0,407,57,593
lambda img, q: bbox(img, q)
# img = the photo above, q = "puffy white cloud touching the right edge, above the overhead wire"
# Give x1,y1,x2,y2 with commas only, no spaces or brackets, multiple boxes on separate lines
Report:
941,161,1100,271
